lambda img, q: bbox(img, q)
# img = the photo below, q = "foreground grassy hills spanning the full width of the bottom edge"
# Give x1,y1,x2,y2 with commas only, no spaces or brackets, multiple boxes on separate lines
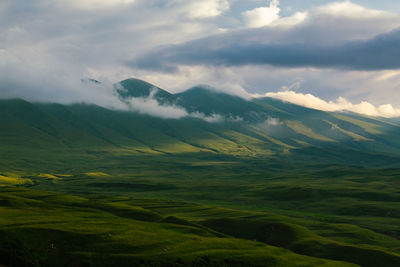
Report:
0,187,400,266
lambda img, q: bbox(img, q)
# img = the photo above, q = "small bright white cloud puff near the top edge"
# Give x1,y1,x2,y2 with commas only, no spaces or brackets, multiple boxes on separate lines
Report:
242,0,281,28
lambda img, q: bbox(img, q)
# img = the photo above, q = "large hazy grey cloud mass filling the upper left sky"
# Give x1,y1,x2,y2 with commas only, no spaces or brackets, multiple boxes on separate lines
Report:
0,0,227,105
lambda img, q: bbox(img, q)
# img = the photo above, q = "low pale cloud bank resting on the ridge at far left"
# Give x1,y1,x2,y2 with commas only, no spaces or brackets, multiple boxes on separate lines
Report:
0,46,122,108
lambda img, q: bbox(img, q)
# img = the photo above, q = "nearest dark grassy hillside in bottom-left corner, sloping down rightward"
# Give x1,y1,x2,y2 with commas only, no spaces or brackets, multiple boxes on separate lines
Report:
0,187,358,266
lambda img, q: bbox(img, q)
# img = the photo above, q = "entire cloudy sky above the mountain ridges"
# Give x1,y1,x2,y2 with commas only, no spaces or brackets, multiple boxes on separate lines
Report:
0,0,400,117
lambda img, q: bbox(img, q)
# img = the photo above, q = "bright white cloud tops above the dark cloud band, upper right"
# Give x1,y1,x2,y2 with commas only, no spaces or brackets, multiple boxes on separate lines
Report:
238,0,400,44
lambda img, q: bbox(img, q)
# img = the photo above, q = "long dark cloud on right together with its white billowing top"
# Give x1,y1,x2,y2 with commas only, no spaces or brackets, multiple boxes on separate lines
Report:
127,0,400,72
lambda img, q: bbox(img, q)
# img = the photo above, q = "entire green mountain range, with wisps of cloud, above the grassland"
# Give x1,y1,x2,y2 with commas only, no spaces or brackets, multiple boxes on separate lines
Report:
0,79,400,170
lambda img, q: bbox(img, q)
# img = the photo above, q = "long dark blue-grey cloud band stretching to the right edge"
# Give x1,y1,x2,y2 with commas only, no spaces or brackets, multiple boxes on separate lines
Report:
128,27,400,71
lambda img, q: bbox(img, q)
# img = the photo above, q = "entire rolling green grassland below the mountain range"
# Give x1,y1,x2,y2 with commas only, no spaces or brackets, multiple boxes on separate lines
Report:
0,150,400,266
